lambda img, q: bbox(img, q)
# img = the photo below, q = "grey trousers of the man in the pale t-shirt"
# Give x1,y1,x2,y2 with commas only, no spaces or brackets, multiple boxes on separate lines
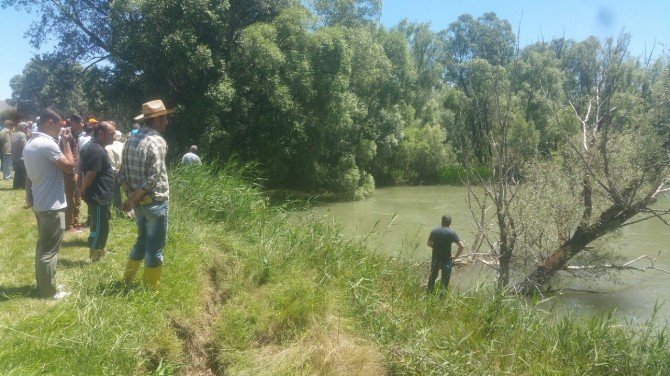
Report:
35,210,65,298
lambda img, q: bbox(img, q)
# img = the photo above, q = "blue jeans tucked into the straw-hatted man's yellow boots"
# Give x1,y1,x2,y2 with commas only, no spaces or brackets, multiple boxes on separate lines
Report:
128,201,168,268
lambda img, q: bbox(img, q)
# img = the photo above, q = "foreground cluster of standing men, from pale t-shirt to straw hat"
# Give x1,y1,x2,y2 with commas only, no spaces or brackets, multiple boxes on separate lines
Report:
21,100,180,299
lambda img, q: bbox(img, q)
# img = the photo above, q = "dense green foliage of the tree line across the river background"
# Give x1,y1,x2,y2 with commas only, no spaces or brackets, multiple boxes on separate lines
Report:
1,0,668,198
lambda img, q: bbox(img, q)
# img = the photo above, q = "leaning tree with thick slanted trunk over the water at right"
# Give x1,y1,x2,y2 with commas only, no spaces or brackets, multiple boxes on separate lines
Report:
513,36,670,294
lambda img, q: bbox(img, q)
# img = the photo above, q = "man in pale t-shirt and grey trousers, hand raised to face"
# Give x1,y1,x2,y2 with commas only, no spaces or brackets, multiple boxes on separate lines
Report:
23,108,74,299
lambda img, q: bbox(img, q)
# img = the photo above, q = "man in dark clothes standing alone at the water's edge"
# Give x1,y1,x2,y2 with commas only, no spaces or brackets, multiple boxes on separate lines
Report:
428,215,464,292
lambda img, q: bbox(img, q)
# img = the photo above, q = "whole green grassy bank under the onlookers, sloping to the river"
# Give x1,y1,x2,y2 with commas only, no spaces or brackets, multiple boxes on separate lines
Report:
0,167,670,375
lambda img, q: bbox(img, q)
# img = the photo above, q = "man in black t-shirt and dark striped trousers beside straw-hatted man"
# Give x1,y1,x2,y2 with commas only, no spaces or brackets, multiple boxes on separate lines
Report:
80,121,116,262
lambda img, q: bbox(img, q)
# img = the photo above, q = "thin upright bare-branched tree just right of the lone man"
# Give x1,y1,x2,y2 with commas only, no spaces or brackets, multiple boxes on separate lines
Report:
467,63,537,290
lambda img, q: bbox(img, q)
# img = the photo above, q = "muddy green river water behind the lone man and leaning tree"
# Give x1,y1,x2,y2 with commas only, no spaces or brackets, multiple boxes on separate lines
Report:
301,186,670,322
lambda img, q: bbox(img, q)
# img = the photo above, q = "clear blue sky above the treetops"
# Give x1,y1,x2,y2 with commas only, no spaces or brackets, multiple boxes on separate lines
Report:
0,0,670,99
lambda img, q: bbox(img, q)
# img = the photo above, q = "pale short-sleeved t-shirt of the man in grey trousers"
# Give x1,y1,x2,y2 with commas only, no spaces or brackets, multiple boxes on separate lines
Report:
23,132,67,211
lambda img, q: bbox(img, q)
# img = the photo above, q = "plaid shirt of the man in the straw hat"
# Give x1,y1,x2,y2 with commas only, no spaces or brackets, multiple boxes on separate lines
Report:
119,127,170,201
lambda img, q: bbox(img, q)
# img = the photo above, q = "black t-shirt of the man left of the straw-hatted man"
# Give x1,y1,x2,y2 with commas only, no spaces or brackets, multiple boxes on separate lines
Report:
79,140,115,205
